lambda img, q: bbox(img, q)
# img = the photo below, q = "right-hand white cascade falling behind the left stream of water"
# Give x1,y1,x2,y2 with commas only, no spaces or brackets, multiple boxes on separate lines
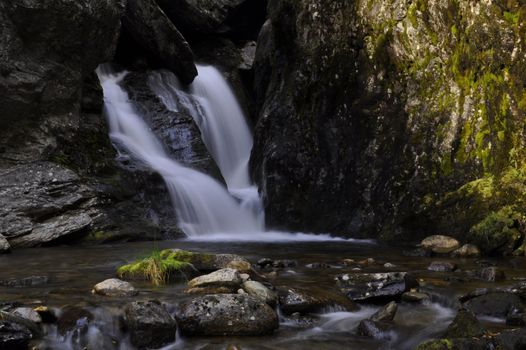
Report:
149,65,264,225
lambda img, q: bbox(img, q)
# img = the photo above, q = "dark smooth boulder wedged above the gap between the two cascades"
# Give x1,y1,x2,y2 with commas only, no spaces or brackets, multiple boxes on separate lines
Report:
123,0,197,84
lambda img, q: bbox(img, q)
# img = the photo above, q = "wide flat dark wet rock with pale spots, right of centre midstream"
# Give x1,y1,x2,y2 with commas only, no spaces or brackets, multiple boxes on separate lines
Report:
336,272,418,302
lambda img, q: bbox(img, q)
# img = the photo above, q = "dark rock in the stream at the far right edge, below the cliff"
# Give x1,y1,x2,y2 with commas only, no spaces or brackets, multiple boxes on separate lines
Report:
464,293,523,318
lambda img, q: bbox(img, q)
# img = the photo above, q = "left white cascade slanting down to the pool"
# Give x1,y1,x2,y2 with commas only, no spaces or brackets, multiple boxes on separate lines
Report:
97,67,263,237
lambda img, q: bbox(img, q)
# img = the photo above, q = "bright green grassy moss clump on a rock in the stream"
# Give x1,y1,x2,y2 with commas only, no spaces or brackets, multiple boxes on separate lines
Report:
117,250,195,286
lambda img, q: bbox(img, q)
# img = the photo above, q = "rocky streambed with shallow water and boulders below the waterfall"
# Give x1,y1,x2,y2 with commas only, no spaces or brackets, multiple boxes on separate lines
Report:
0,240,526,350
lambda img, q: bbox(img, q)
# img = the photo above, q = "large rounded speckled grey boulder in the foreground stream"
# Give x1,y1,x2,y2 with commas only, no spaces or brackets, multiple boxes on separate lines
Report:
177,294,279,336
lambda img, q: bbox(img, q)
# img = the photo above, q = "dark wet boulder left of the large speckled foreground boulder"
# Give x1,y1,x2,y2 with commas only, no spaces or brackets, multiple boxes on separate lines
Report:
124,301,177,349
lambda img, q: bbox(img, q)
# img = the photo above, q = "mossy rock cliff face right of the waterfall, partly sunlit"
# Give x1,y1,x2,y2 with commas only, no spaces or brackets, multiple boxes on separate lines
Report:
252,0,526,250
